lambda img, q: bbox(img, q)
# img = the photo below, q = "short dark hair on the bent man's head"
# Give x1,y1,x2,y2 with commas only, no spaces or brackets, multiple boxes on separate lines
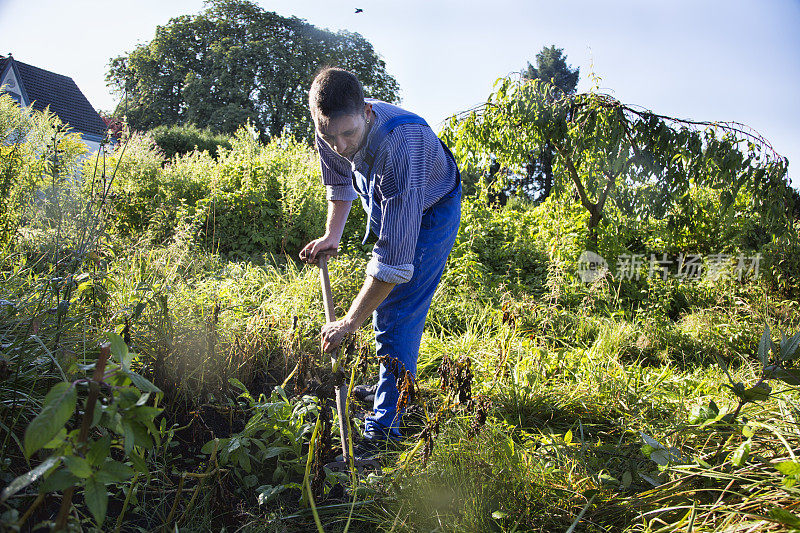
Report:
308,67,364,118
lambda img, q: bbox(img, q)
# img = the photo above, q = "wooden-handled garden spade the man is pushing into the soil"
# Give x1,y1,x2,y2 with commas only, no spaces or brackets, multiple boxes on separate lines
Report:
317,256,380,472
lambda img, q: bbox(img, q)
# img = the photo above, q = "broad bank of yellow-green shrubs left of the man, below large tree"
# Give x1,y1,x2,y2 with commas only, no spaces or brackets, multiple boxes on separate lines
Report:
85,123,336,260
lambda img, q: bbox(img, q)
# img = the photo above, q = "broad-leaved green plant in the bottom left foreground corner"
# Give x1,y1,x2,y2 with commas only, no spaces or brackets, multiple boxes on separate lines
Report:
0,334,162,530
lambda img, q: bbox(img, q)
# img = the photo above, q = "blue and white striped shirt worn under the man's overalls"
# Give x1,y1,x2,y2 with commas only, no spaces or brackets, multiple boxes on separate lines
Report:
316,99,458,283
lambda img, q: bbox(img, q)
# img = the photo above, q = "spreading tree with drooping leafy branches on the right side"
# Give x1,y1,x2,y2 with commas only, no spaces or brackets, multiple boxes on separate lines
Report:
443,77,791,251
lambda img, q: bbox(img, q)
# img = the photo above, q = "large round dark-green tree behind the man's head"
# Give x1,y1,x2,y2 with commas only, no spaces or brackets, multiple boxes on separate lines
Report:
106,0,398,139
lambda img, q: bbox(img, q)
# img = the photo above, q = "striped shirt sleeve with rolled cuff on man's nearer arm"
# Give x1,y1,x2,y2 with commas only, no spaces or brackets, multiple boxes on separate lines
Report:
367,126,433,284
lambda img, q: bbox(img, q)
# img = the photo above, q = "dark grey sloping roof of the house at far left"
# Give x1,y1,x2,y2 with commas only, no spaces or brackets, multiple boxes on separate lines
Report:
0,56,106,137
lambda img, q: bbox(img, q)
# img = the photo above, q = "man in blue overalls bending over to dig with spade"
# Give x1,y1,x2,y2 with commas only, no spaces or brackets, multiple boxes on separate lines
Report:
300,68,461,455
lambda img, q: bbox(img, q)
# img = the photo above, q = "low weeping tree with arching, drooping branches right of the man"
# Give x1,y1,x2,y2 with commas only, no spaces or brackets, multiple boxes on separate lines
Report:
445,74,786,250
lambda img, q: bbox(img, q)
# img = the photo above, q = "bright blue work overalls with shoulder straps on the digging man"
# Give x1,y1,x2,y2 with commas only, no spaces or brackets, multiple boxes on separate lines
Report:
354,114,461,438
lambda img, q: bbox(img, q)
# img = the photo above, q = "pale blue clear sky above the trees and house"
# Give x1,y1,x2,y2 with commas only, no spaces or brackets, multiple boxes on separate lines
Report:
0,0,800,187
